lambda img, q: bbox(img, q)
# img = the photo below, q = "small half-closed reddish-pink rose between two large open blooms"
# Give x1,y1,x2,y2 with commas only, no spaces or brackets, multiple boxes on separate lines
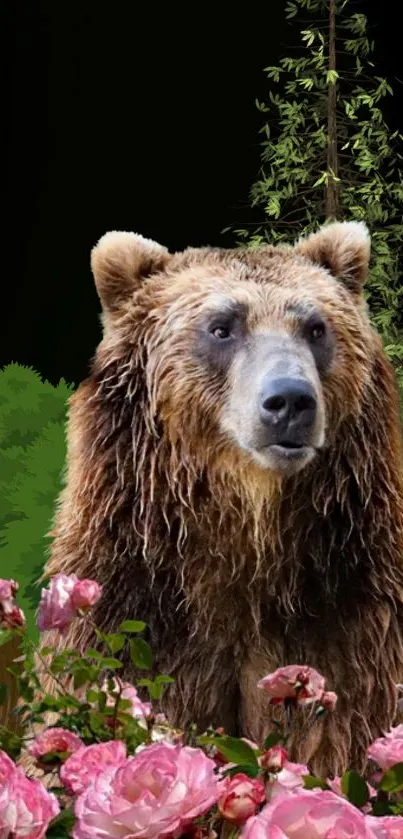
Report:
218,773,266,824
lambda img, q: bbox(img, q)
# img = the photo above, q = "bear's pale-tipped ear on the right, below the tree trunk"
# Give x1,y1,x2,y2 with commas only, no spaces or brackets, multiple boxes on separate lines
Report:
294,221,371,294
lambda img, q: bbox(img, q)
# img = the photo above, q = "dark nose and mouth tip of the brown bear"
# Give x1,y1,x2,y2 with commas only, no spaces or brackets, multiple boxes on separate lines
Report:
259,377,317,436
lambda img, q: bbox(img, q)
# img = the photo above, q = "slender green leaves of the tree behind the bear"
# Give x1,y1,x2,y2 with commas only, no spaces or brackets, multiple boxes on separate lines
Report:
236,0,403,389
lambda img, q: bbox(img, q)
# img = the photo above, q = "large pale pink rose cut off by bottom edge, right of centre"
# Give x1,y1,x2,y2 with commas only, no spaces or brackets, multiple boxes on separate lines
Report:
242,790,376,839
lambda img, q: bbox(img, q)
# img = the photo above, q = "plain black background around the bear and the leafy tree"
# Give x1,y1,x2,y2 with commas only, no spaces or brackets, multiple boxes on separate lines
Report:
0,0,403,384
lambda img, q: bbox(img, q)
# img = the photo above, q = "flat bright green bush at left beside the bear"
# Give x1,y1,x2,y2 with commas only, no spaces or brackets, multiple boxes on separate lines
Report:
0,364,73,634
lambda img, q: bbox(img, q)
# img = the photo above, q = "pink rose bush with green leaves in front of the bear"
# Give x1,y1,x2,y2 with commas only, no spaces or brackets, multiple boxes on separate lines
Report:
0,574,403,839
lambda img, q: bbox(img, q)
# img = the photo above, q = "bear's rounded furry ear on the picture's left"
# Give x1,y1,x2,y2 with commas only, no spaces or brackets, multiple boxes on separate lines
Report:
91,230,170,312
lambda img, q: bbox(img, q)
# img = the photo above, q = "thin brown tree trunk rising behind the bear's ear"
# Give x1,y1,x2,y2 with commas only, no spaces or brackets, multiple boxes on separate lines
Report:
325,0,339,219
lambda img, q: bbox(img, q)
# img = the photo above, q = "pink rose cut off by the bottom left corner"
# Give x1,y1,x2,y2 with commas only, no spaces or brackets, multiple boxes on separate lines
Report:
0,753,60,839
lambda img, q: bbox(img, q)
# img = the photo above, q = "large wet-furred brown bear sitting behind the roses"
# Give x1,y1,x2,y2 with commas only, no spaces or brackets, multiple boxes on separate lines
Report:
41,222,403,773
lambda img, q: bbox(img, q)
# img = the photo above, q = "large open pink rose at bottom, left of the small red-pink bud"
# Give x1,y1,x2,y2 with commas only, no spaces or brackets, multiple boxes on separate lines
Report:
70,744,220,839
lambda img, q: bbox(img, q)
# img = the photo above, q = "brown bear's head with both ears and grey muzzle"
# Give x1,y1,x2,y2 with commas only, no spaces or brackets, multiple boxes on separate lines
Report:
92,222,380,476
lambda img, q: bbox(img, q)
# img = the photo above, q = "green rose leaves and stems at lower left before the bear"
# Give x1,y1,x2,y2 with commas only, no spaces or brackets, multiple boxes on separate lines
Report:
0,618,167,770
